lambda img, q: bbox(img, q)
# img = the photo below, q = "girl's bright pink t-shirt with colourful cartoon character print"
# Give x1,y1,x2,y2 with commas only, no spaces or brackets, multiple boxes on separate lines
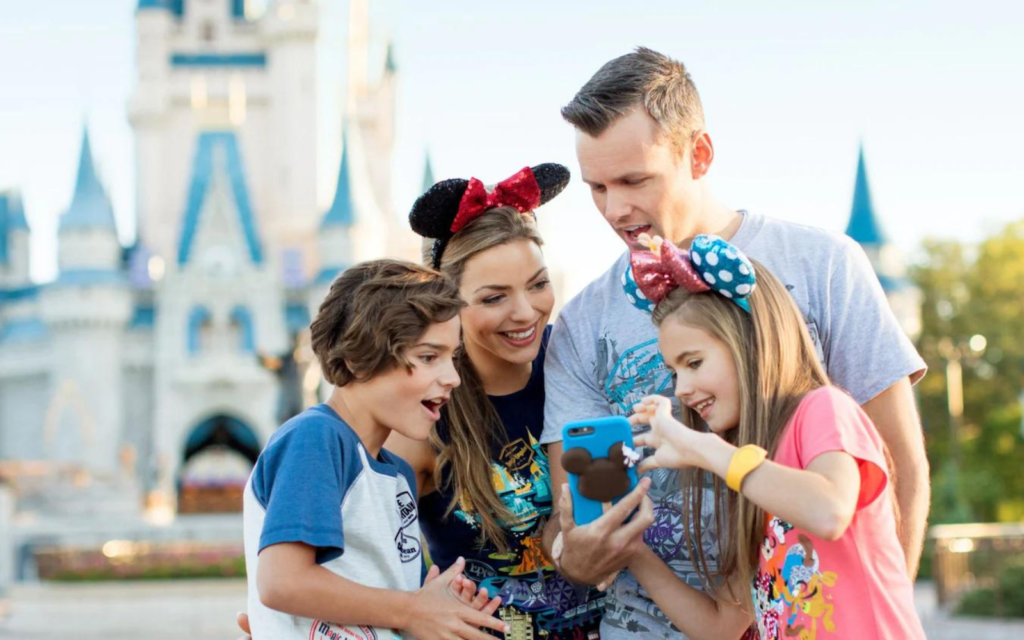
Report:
751,387,925,640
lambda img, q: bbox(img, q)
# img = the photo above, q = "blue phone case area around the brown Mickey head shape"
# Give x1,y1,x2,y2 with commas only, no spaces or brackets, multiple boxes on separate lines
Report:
556,416,638,526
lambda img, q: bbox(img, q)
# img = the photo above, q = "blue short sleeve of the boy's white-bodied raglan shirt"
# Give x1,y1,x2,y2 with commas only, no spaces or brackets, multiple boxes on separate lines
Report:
252,421,346,563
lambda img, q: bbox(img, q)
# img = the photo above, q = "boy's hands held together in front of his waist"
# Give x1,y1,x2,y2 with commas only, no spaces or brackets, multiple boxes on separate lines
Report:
404,558,509,640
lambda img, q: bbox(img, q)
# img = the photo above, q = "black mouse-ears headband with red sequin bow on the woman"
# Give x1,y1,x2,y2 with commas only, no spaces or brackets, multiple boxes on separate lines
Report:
409,163,569,269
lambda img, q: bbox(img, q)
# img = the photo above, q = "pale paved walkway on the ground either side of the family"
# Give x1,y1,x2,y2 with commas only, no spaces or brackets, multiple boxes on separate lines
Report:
0,580,1024,640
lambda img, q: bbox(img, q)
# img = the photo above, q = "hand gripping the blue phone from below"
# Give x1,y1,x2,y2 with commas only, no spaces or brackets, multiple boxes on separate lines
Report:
558,478,654,585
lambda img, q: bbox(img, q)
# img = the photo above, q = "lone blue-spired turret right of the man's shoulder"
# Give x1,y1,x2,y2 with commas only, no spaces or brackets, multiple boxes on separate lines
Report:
846,146,921,339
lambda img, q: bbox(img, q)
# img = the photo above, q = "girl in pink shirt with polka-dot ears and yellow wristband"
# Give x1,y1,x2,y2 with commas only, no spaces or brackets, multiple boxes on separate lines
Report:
630,236,925,640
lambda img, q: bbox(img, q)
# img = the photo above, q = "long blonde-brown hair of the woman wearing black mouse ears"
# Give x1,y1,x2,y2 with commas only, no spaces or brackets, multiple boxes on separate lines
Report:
423,207,544,553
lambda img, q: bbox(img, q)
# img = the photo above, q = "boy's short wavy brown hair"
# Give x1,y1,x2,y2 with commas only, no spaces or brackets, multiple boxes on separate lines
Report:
310,259,465,387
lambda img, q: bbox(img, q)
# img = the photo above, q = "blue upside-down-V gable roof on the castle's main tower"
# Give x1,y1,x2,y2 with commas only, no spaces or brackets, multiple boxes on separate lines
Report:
178,131,263,265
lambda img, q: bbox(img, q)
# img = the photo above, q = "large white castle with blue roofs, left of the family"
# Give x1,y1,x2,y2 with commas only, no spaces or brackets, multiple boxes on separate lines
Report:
0,0,418,564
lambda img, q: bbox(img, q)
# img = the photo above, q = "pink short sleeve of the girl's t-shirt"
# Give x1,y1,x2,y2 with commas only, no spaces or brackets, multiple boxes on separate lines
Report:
793,387,889,510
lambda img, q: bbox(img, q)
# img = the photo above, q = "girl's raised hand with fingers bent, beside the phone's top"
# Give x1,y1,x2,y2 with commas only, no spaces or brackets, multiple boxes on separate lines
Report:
630,395,705,472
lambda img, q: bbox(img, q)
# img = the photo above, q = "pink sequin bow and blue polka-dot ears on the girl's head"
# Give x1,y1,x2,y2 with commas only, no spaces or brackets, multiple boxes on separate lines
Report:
623,234,757,313
